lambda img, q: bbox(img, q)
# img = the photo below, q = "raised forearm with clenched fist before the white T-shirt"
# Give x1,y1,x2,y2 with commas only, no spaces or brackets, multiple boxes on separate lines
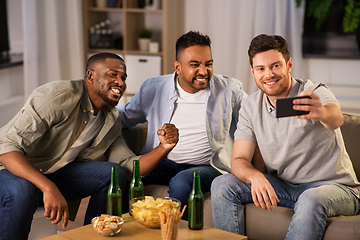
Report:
139,123,179,176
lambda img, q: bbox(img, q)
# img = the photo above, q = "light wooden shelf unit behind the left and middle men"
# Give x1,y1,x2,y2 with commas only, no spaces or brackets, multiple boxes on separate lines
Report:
83,0,184,74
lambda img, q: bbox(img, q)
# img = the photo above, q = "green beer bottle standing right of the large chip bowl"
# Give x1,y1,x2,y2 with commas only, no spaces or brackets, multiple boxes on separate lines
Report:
188,171,204,230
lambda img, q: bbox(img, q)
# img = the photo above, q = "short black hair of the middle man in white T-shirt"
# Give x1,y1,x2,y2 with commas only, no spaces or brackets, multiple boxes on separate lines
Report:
175,31,211,60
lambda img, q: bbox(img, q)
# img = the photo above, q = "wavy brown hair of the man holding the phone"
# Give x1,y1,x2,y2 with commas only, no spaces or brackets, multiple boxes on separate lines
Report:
248,34,290,67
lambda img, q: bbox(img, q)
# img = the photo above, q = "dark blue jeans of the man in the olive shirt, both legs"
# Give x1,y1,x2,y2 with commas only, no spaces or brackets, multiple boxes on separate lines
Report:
0,162,126,240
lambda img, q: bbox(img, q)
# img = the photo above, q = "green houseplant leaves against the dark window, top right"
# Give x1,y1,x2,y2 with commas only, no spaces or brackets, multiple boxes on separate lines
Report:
295,0,360,33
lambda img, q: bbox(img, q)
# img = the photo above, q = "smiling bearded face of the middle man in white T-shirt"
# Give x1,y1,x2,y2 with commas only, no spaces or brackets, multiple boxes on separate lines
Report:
174,45,213,93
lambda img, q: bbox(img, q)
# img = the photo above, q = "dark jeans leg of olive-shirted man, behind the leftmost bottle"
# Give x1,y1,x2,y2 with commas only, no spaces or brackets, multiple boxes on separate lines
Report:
46,162,126,225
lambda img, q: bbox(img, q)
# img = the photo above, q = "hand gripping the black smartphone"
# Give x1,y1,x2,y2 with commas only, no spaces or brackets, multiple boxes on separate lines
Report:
293,91,326,121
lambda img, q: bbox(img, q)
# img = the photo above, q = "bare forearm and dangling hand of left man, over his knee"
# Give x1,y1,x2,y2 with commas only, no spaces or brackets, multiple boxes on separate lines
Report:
0,152,69,228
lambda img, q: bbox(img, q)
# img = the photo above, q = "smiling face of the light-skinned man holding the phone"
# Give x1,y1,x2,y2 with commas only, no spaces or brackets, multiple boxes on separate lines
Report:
251,50,293,101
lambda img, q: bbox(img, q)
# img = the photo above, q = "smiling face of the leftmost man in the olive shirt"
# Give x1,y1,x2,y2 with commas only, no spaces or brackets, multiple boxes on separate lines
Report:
85,58,127,112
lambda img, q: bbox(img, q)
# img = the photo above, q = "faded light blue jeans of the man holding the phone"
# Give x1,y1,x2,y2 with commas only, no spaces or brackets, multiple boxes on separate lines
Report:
211,174,359,240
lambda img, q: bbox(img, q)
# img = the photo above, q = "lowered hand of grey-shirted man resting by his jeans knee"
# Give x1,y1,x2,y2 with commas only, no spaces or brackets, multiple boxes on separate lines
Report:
251,175,280,211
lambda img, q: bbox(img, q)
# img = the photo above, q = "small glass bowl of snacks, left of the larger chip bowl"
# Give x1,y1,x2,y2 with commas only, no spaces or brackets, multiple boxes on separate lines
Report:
91,214,124,236
